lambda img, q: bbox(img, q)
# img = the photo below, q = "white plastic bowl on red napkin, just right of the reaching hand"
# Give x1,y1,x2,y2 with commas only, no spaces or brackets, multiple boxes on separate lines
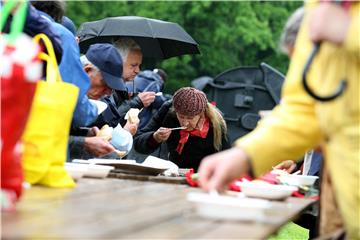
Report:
239,182,298,200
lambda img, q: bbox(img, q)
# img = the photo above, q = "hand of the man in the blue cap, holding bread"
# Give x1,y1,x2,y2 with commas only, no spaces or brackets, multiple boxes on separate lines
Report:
84,137,115,157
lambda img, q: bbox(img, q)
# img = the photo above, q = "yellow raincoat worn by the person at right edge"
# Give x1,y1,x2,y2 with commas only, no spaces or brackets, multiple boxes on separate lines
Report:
235,2,360,239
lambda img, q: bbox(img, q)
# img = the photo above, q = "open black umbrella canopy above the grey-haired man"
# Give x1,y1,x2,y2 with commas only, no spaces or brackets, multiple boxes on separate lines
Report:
78,16,200,59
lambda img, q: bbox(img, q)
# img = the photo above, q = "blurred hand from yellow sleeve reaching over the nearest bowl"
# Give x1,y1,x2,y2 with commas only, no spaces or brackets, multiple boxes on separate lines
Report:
198,147,250,191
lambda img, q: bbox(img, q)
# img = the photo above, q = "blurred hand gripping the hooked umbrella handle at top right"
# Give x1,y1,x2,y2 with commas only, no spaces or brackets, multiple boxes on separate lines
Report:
309,2,351,45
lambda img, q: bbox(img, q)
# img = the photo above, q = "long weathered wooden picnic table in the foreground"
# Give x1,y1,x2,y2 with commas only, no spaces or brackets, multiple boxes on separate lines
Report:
2,178,314,239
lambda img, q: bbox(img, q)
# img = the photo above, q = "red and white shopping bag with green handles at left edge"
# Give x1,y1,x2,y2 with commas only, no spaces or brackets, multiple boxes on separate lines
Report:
0,1,42,201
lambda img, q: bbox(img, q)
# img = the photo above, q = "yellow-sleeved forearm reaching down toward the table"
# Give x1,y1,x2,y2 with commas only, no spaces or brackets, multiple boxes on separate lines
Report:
235,99,322,175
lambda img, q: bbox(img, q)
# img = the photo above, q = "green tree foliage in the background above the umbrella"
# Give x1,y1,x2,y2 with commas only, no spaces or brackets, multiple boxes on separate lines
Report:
66,1,302,93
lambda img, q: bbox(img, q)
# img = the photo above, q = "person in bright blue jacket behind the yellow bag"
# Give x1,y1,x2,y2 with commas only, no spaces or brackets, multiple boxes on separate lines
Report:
31,0,97,128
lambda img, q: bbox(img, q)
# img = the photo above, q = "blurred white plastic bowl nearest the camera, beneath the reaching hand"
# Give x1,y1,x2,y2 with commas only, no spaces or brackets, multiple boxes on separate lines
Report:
187,192,287,223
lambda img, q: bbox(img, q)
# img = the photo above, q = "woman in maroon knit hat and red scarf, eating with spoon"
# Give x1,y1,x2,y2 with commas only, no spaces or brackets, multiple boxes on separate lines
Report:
134,87,230,171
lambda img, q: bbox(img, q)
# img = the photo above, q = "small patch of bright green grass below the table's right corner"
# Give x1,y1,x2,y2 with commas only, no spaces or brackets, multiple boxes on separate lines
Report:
269,223,309,240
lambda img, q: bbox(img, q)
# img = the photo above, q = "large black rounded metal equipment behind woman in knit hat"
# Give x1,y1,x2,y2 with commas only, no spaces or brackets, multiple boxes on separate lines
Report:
203,63,284,142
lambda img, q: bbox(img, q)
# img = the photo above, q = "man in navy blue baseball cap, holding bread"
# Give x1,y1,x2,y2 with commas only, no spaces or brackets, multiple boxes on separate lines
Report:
69,43,132,159
